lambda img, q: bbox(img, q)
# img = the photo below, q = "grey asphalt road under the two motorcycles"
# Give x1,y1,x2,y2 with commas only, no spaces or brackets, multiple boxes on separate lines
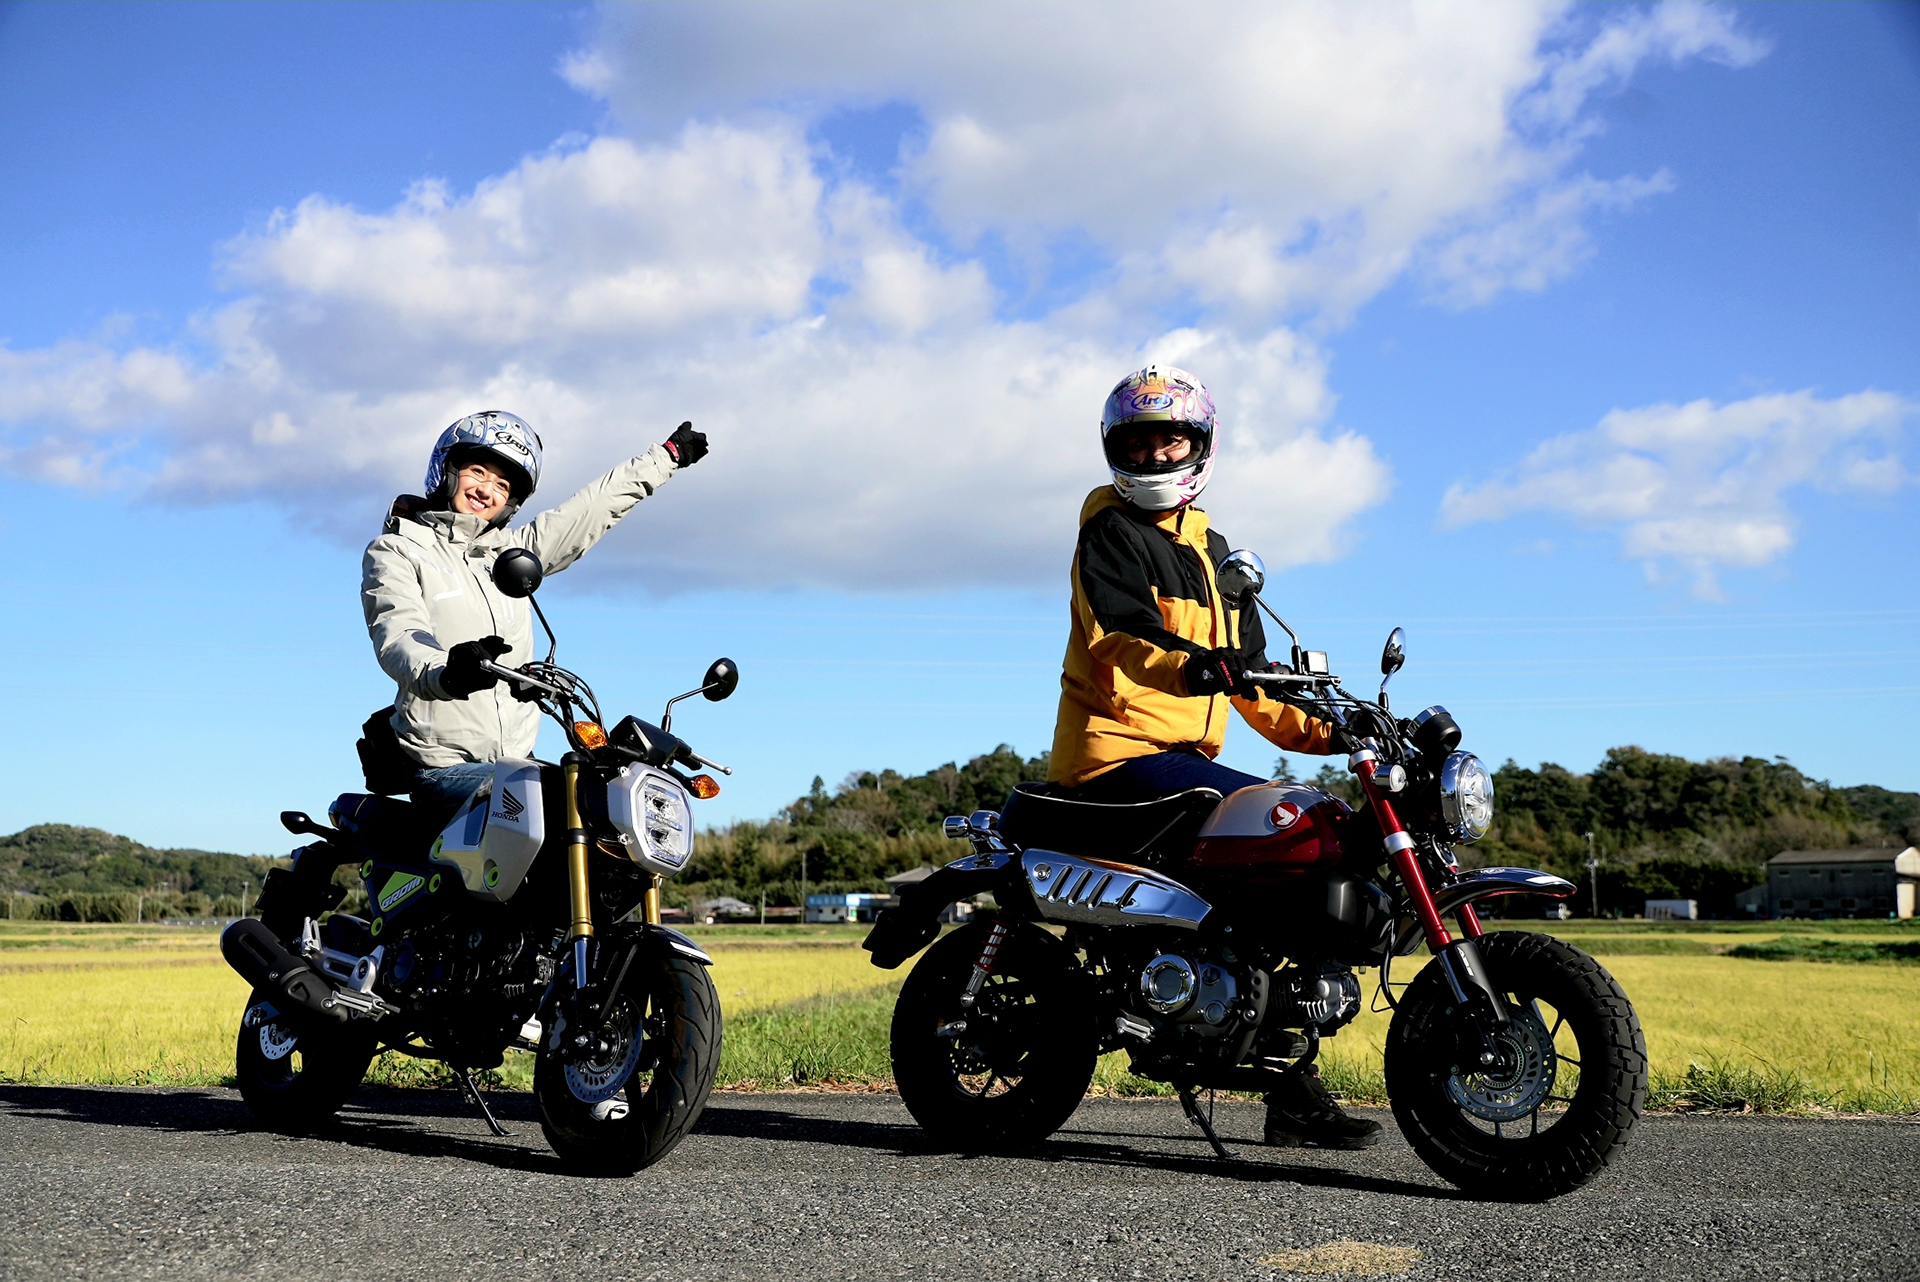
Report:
0,1086,1920,1282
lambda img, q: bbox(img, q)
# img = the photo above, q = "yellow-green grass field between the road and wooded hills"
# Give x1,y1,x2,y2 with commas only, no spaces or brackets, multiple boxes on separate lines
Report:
0,921,1920,1113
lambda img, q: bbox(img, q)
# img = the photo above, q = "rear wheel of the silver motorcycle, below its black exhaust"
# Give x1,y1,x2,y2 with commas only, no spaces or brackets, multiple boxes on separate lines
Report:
234,992,378,1134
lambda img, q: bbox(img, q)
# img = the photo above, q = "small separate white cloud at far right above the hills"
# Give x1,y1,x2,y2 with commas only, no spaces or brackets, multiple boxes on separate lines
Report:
1440,392,1916,595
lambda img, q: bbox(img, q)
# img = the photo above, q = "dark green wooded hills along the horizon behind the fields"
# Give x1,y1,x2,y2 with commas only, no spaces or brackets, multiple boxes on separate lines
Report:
11,745,1920,921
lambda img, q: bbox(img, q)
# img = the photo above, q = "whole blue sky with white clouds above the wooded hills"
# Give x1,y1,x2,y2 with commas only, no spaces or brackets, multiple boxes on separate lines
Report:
0,4,1920,850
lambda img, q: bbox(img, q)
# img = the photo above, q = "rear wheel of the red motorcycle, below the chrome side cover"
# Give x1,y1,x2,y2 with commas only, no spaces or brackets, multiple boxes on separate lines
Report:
893,923,1100,1151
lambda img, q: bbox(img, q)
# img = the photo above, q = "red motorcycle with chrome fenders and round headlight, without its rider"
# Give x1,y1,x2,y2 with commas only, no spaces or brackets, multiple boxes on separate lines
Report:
866,553,1647,1199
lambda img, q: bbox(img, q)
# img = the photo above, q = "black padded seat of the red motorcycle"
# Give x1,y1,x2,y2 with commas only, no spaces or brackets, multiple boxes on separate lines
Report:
1000,783,1219,864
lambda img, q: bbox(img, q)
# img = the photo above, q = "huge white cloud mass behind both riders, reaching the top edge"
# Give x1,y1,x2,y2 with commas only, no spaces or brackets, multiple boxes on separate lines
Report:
0,2,1766,587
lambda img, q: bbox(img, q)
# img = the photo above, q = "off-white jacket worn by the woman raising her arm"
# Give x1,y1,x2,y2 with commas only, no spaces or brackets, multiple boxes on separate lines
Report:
361,445,674,766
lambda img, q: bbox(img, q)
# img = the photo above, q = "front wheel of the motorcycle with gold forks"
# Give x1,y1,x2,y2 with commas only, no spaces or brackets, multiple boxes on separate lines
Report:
534,954,720,1175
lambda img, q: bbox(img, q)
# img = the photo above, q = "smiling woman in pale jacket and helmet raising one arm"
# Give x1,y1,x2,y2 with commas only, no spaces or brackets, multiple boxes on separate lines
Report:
361,411,707,821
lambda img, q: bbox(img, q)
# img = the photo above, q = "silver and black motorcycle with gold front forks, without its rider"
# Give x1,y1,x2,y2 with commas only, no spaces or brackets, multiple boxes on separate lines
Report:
221,549,739,1173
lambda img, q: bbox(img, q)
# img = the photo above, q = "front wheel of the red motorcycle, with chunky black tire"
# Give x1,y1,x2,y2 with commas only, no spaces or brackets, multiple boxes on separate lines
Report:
1386,931,1647,1201
